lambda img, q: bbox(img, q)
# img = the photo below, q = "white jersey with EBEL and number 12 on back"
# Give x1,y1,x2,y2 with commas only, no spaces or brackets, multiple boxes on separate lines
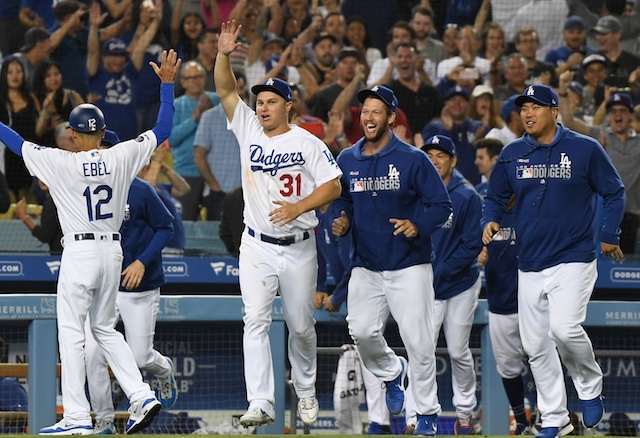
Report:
22,131,157,235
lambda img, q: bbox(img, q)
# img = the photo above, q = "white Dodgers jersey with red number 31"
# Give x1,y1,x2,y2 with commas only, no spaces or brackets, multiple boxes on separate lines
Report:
228,101,342,236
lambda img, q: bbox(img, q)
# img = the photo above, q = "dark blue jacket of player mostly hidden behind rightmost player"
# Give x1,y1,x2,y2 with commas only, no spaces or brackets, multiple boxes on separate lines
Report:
484,210,518,315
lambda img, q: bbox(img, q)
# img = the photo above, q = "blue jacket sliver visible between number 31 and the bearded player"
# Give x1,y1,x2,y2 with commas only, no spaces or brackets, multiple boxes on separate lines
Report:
316,206,351,307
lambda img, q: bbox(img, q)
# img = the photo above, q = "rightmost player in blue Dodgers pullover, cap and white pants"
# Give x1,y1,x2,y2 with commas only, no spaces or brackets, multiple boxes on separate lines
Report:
482,85,625,438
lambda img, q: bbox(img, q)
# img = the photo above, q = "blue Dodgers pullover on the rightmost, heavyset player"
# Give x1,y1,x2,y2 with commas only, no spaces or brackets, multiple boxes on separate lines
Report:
482,125,625,271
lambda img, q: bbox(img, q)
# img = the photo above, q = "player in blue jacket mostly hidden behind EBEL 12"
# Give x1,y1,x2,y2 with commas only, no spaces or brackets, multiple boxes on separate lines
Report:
85,130,178,434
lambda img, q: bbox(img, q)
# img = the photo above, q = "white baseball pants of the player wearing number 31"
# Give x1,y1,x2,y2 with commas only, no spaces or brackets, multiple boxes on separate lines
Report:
239,230,318,418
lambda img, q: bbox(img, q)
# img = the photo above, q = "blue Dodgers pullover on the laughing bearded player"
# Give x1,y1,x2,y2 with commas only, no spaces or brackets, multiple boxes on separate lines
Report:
332,133,451,271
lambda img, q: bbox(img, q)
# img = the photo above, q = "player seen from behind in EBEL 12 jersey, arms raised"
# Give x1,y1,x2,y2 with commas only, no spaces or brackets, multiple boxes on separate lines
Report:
0,50,181,435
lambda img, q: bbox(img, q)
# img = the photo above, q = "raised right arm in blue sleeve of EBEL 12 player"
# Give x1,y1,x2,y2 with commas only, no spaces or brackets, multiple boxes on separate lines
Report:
149,49,182,146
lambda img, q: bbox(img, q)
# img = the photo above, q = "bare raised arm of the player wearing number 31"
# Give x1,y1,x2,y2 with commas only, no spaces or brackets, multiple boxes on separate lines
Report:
213,20,242,121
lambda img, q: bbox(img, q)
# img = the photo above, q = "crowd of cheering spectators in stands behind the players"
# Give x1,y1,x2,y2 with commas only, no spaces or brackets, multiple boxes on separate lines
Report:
0,0,640,253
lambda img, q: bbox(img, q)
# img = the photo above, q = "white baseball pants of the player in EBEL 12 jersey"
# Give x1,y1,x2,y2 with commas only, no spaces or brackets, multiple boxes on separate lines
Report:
56,239,154,425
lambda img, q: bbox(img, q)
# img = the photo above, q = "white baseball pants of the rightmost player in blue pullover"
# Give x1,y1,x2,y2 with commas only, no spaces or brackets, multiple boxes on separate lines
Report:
518,260,602,427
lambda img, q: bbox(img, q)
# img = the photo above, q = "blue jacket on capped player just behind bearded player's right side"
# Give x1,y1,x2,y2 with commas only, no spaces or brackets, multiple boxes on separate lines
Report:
431,169,482,300
